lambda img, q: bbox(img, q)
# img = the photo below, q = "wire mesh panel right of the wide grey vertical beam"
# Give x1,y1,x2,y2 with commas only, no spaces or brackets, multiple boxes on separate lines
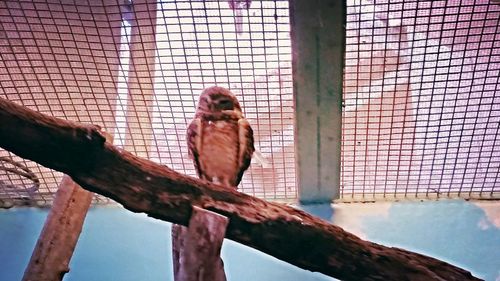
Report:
341,0,500,200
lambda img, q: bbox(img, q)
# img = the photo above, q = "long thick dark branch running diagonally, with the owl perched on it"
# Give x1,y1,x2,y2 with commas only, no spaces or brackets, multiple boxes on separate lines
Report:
0,99,479,280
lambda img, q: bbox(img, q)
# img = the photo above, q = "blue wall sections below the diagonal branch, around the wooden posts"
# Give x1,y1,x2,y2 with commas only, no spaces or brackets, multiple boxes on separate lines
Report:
0,207,334,281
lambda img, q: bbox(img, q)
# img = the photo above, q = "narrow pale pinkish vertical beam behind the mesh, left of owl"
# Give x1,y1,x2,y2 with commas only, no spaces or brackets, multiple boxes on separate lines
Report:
124,0,157,158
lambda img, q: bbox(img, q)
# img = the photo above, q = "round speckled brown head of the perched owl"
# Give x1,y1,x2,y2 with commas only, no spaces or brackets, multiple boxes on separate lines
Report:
197,86,241,114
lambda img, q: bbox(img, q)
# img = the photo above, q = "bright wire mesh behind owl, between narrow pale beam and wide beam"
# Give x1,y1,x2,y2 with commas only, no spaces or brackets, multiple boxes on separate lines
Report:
152,1,297,200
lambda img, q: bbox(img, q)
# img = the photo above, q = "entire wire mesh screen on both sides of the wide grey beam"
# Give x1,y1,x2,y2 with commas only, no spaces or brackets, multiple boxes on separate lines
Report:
0,0,500,205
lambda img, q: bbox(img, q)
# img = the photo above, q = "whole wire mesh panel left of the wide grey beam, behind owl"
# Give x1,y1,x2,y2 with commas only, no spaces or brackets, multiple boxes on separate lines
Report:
0,0,297,205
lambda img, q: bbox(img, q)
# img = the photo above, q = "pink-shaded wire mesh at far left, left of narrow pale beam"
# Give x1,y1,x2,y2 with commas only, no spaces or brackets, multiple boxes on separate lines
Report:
0,1,121,206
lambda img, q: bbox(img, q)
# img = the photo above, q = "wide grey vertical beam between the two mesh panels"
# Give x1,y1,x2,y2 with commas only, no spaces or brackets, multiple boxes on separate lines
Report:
290,0,346,203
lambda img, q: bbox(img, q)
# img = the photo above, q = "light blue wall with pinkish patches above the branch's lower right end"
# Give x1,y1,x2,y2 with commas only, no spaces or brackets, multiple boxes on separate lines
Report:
332,200,500,281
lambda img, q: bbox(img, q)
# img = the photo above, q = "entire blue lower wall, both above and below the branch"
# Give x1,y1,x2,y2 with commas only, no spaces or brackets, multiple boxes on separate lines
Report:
0,200,500,281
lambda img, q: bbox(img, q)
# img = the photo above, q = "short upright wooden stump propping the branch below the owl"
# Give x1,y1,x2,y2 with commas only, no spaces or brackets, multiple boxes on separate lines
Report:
172,207,228,281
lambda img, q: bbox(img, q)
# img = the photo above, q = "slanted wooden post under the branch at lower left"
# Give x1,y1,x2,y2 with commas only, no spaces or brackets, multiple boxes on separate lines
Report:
21,176,93,281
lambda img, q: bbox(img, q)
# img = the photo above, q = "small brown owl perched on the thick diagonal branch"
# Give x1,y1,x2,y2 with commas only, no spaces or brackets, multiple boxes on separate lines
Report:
187,86,255,188
